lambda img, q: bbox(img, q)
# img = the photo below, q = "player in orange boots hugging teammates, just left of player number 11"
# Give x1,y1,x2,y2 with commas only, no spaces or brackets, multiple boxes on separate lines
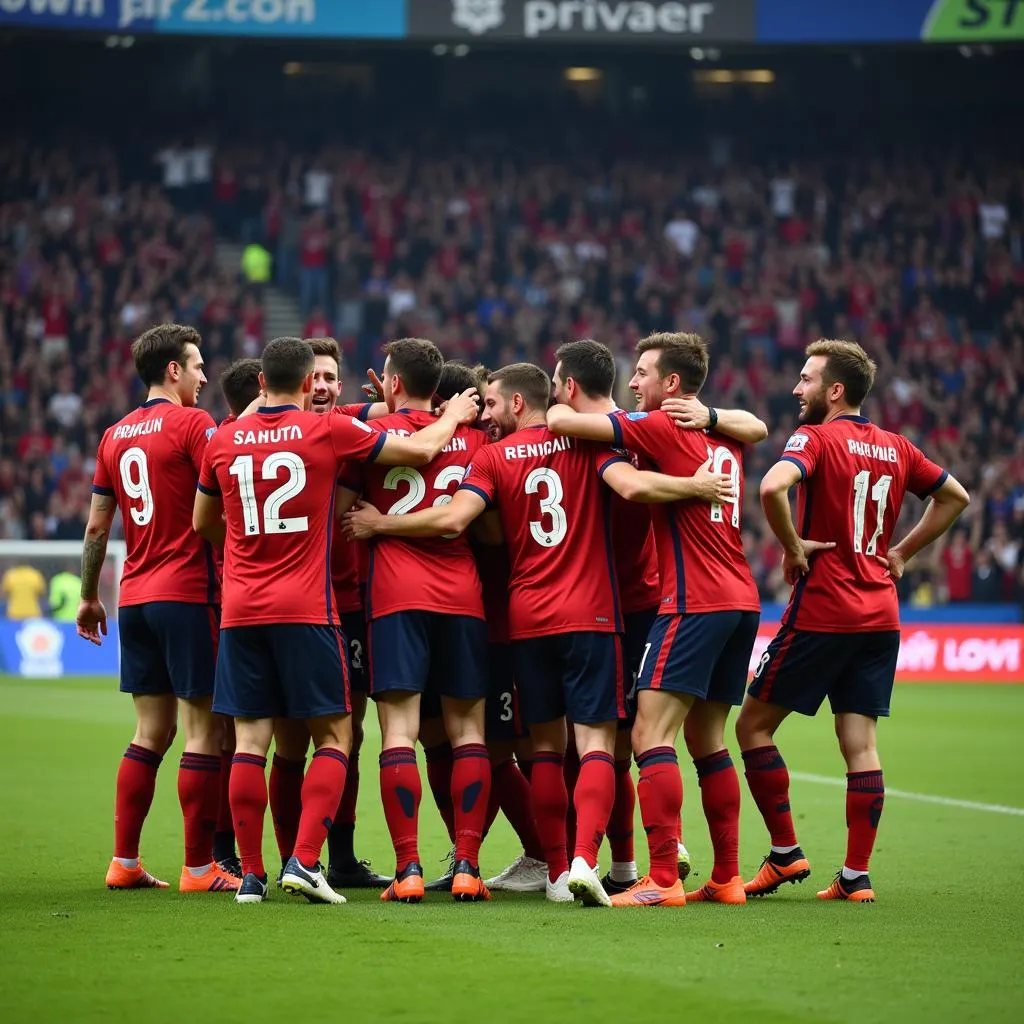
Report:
548,334,767,906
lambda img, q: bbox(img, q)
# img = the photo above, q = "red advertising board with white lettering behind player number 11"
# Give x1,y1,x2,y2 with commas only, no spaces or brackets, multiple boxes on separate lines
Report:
751,623,1024,683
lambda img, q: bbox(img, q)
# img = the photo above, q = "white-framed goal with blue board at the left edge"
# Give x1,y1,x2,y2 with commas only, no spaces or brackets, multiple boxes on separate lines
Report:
0,541,125,678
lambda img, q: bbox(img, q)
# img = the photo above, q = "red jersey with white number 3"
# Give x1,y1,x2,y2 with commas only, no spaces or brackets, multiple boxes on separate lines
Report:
462,425,623,640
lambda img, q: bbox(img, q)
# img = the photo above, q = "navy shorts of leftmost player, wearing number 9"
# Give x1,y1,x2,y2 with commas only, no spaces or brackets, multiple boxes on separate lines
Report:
118,601,220,700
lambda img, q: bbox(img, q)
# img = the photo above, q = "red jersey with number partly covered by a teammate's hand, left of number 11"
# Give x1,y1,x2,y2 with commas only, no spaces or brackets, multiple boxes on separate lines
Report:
608,412,761,614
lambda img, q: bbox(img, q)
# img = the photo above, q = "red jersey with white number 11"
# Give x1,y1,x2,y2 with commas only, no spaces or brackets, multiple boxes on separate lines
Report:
782,416,947,633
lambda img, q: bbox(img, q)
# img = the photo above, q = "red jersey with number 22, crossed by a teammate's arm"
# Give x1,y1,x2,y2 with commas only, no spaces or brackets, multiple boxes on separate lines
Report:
343,410,486,618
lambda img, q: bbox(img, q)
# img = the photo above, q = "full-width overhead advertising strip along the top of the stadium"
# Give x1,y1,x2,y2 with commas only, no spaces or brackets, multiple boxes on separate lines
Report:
0,0,1024,45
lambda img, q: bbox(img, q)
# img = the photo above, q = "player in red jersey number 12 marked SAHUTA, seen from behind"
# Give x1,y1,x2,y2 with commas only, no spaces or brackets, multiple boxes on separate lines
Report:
193,338,475,903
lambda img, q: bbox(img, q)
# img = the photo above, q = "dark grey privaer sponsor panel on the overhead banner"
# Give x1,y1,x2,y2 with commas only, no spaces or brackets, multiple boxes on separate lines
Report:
408,0,757,43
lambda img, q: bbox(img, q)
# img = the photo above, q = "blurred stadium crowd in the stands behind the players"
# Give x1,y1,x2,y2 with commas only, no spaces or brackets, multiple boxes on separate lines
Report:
0,135,1024,605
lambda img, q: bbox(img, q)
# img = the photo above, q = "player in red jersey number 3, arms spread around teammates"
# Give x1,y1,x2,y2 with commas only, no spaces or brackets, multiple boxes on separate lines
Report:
345,362,729,906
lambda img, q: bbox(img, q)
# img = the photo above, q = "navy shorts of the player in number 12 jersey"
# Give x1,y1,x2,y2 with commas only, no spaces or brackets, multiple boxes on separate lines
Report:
213,623,352,718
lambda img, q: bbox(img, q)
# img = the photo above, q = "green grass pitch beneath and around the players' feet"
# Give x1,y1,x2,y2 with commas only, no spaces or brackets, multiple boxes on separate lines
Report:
0,678,1024,1024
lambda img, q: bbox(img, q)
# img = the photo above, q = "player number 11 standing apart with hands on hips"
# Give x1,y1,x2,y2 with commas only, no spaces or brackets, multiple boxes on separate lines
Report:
736,340,970,903
